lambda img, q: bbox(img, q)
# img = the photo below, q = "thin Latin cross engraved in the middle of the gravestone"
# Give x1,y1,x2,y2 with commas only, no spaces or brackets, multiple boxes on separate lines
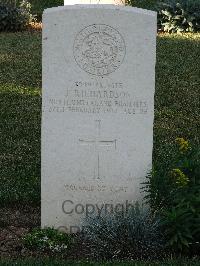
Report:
79,120,117,179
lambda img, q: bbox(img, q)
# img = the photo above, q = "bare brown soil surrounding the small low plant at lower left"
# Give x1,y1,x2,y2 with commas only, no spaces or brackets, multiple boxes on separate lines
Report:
0,204,90,260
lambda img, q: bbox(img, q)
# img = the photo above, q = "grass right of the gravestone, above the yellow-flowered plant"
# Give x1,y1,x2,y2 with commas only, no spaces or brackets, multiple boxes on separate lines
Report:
153,34,200,162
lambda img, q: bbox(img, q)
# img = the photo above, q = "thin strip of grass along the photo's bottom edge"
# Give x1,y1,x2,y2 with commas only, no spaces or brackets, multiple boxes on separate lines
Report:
0,259,200,266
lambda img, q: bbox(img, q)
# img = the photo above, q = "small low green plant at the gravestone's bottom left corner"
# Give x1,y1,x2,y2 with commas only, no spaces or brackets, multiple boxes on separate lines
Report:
23,228,72,253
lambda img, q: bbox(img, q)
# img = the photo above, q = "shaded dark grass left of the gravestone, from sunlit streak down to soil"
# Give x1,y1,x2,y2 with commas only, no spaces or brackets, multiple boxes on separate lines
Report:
0,88,41,205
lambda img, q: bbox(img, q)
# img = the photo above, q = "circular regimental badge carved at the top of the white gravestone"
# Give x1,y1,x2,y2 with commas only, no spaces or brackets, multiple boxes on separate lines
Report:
74,24,126,76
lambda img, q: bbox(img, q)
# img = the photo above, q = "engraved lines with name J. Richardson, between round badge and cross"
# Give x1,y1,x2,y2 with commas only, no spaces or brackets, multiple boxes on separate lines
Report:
43,81,149,116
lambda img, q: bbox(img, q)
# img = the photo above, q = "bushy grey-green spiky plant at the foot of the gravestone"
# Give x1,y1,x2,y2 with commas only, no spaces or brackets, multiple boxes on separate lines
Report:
83,206,164,259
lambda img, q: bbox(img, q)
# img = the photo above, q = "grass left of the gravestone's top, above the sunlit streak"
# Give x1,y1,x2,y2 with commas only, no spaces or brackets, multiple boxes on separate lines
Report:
0,31,42,90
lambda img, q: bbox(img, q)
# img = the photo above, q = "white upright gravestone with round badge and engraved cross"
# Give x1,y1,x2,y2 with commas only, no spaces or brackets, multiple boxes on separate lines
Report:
41,5,156,232
